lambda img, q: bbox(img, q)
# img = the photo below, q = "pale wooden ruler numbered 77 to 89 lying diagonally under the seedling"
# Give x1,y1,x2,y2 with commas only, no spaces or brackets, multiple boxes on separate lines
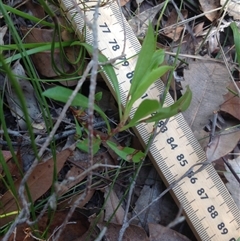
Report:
61,0,240,241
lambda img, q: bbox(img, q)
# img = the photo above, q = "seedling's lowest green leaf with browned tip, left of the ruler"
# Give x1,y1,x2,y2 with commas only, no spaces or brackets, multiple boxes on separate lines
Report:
106,141,145,163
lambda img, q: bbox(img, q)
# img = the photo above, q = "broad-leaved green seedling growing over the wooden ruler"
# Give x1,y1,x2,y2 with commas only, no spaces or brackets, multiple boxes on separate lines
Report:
43,25,192,162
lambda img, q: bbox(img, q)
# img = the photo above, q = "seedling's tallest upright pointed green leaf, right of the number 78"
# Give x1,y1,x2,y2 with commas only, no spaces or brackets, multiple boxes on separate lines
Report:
129,24,156,95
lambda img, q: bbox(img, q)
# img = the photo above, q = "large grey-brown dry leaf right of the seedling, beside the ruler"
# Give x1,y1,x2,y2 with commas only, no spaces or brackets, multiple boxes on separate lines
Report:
181,60,229,131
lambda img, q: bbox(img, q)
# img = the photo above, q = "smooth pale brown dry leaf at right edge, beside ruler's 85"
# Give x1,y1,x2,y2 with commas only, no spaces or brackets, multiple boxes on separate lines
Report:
206,128,240,162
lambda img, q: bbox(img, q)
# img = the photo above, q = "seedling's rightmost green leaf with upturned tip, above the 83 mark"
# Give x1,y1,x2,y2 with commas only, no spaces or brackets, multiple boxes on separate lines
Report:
144,86,192,123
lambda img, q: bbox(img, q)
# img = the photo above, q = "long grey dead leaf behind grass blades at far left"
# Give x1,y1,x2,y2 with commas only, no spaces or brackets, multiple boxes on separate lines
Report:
6,61,41,130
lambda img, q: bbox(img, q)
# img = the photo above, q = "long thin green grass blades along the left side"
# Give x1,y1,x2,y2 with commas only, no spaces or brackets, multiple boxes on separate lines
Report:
0,2,62,235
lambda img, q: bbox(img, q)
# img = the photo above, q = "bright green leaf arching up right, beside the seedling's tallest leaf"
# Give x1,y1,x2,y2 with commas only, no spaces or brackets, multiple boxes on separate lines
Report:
128,65,173,105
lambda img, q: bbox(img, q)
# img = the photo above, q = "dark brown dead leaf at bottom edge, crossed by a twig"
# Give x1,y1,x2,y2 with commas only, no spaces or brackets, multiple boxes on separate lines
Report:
98,223,149,241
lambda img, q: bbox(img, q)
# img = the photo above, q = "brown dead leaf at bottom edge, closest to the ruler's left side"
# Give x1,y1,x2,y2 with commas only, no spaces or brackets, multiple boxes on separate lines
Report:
148,223,190,241
